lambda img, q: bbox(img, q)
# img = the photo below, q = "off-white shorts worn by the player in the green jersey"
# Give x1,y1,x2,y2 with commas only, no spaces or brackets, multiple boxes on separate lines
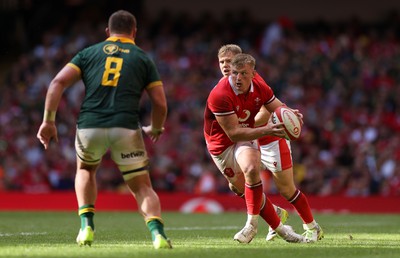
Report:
75,127,149,178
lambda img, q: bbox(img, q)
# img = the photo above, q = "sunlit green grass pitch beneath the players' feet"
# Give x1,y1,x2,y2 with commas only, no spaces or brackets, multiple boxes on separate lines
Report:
0,211,400,258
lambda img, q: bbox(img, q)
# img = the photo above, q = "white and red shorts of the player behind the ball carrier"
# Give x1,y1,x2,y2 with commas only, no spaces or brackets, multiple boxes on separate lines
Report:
260,139,293,173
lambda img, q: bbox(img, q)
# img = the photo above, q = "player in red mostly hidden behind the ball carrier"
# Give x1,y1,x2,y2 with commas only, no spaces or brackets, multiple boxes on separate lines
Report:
212,44,324,242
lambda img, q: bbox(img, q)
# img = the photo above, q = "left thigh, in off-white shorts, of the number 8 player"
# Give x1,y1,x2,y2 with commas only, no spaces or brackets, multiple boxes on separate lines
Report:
75,128,108,165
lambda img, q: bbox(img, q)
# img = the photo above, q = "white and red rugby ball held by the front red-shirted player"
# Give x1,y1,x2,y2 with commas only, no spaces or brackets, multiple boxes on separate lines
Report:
271,106,301,141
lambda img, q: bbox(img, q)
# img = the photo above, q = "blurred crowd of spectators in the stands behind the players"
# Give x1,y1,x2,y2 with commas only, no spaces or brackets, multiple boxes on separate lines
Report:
0,5,400,196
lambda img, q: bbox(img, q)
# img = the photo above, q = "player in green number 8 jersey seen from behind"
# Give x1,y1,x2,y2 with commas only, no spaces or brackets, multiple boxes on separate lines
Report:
37,10,172,249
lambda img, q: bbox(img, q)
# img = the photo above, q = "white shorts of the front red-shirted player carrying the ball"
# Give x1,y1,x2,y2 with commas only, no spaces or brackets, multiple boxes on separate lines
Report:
211,141,258,183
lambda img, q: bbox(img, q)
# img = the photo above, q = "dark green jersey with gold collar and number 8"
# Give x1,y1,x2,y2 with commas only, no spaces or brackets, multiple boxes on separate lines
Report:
68,37,162,129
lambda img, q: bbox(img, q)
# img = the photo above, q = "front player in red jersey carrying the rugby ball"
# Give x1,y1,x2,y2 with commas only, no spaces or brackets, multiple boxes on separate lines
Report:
204,54,305,243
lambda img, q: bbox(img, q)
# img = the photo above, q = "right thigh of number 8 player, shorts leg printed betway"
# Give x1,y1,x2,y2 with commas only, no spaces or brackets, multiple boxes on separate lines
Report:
109,128,149,181
